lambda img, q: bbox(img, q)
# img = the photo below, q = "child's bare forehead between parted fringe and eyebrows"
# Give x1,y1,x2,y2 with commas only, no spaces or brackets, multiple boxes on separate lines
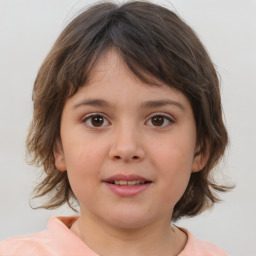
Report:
65,49,190,114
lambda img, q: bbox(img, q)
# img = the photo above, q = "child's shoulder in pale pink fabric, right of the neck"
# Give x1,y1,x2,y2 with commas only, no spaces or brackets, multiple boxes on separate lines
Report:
179,228,228,256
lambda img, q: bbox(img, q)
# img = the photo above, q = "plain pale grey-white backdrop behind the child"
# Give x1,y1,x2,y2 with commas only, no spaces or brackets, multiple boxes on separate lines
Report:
0,0,256,256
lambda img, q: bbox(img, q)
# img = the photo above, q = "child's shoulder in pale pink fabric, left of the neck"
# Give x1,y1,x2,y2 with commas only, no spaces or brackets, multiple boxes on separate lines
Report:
0,216,91,256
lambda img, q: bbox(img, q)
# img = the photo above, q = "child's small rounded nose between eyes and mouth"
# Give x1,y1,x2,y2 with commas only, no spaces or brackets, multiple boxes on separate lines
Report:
109,124,145,162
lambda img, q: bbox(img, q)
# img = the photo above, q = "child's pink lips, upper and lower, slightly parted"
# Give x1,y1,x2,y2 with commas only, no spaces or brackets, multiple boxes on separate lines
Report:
103,174,152,197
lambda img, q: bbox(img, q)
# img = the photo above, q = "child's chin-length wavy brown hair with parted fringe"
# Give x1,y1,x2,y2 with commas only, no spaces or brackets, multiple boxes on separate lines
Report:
27,1,232,220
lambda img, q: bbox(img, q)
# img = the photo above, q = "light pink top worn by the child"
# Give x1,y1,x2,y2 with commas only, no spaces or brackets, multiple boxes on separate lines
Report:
0,216,227,256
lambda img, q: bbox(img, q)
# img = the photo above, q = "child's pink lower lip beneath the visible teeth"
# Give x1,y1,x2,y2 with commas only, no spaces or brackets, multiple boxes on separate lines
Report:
105,182,152,197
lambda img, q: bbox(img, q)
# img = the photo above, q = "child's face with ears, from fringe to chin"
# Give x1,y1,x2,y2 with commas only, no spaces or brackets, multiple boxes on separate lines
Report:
54,50,208,228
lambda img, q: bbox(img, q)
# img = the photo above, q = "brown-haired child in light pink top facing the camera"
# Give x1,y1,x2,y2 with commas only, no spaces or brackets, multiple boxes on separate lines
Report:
0,1,231,256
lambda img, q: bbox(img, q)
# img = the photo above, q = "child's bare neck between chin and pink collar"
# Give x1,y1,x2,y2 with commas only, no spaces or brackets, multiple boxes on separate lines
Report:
71,209,187,256
